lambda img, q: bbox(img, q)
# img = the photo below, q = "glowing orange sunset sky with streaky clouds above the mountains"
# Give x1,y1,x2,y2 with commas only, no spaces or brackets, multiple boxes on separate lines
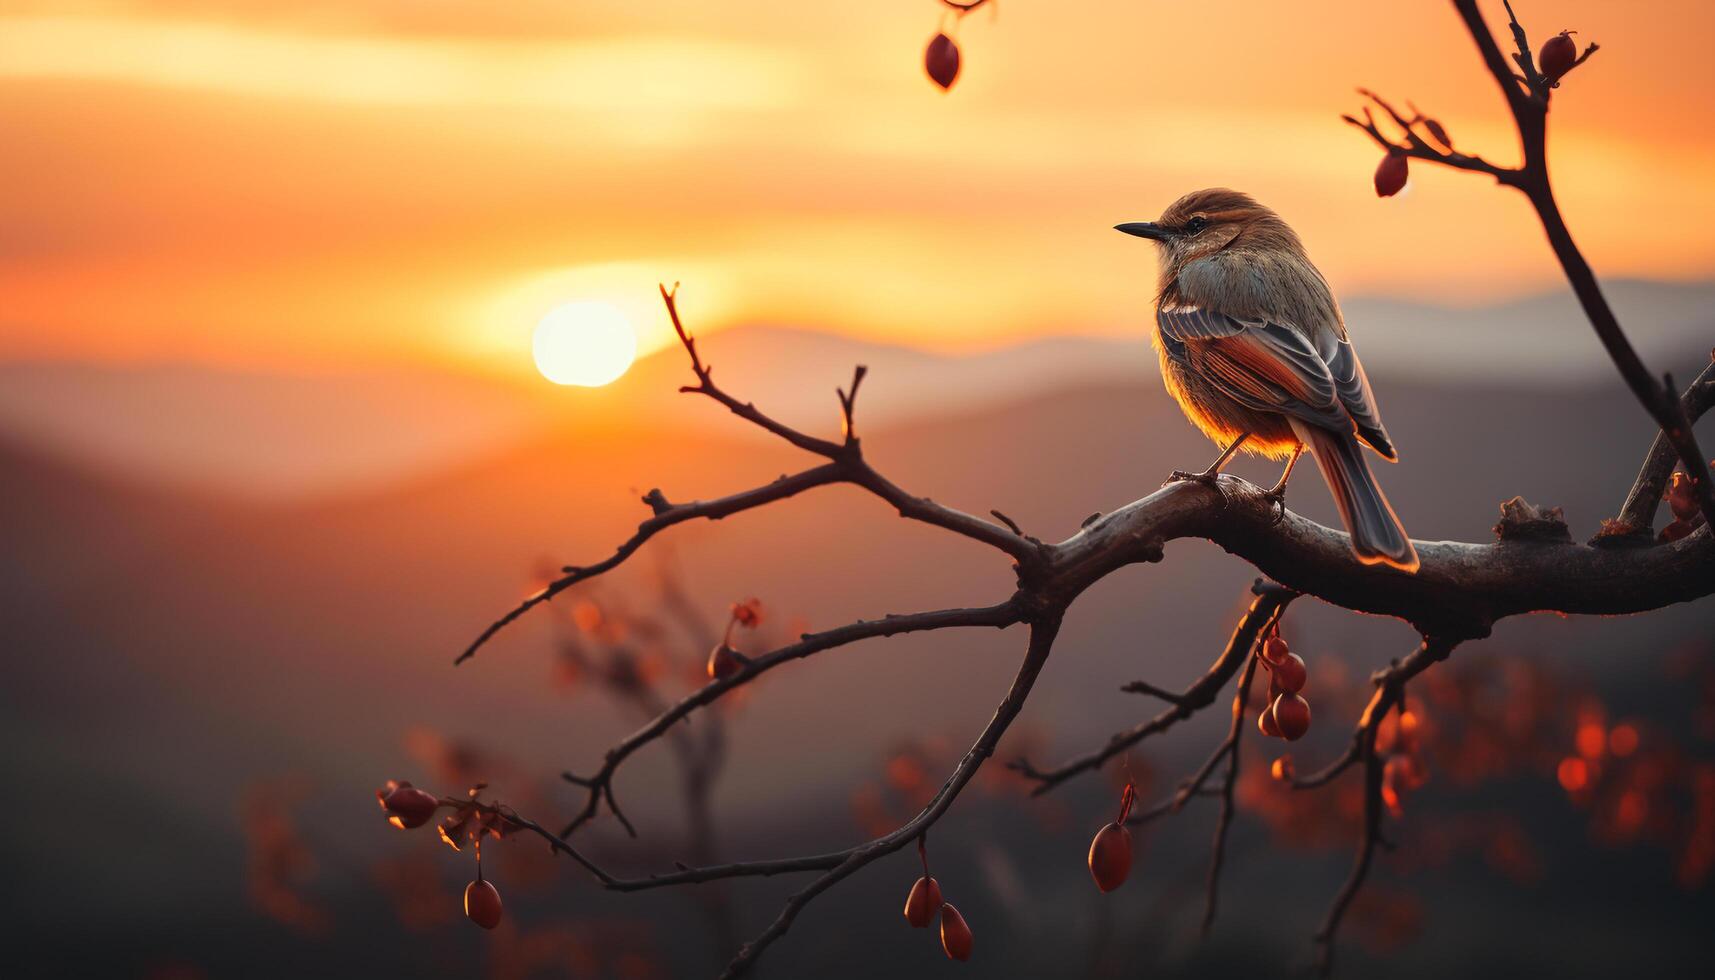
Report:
0,0,1715,371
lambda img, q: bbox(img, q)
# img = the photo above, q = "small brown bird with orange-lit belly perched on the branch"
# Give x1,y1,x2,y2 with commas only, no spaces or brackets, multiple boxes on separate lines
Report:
1115,187,1420,573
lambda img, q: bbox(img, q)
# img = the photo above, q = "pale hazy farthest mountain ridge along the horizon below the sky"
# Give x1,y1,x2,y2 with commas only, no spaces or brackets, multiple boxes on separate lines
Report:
0,280,1715,501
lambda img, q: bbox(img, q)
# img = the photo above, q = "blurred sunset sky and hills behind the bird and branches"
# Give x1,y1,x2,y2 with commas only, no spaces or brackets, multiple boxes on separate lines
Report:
0,0,1715,978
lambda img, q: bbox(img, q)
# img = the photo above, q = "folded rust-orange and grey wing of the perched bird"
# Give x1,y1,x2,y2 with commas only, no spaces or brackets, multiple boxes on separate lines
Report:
1156,307,1393,458
